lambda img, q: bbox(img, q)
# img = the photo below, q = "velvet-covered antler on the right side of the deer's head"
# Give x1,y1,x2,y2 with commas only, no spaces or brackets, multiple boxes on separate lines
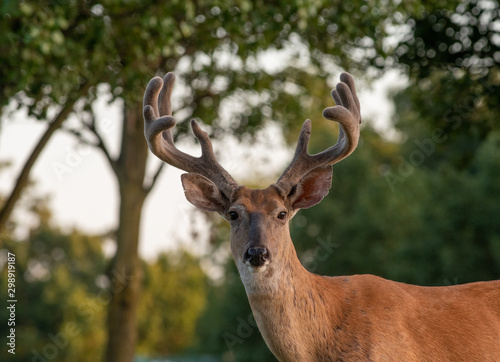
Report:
276,73,361,194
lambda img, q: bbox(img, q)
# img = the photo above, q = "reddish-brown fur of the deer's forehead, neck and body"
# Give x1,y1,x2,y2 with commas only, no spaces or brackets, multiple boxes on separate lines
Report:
226,187,500,362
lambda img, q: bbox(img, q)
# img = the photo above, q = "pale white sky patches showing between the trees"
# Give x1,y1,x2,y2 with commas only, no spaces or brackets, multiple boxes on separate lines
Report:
0,68,405,258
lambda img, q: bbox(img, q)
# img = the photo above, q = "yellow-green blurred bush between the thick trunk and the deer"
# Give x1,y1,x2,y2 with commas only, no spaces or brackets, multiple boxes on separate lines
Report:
137,251,207,356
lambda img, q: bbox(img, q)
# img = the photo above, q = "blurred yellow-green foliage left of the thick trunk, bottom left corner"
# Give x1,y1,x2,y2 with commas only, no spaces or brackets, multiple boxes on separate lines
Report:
0,202,107,361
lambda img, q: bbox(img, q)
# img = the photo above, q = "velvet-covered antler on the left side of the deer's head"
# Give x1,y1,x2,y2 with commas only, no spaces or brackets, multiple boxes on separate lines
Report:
143,73,238,198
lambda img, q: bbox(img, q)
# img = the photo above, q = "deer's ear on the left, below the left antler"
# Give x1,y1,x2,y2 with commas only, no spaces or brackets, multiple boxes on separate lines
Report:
181,173,227,213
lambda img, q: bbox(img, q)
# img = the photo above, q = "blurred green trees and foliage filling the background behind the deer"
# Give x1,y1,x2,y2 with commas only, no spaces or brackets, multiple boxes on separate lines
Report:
0,0,500,361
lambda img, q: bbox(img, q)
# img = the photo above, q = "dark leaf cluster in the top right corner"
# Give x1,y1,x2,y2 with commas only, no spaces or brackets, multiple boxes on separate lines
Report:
393,0,500,78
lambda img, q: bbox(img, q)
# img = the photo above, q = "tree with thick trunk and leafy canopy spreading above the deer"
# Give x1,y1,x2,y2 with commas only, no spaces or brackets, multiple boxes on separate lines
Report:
0,0,450,361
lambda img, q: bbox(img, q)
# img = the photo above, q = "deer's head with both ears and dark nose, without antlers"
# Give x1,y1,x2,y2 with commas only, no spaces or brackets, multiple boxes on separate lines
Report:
182,165,332,276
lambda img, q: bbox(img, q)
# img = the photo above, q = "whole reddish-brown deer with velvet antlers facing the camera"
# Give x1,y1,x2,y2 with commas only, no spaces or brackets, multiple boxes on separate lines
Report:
144,73,500,362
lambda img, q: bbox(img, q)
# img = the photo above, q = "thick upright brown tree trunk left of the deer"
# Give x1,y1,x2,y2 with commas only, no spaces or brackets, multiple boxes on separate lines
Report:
106,102,148,362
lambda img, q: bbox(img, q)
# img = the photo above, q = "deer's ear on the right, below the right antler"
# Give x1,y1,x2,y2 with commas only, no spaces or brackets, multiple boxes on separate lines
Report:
289,165,332,210
